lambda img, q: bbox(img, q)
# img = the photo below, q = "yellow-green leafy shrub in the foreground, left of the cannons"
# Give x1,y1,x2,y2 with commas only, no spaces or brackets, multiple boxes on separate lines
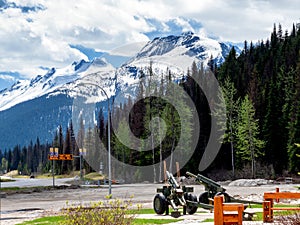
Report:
60,199,135,225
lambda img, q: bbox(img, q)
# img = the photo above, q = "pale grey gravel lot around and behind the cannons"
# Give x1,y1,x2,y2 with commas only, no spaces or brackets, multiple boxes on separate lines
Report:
0,178,300,225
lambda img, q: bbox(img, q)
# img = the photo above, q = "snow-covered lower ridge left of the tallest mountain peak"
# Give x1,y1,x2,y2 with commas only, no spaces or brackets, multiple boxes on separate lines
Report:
0,58,114,111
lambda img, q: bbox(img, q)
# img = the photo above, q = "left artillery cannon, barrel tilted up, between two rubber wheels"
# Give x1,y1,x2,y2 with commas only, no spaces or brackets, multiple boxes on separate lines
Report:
153,171,198,217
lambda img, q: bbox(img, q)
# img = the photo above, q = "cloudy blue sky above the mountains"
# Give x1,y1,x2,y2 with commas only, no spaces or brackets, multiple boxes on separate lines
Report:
0,0,300,89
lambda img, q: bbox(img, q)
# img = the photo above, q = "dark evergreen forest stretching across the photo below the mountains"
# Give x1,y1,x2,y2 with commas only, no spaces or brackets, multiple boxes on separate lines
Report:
0,25,300,181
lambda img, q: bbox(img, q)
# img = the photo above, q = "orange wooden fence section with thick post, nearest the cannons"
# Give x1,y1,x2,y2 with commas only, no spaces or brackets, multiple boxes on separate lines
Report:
214,195,244,225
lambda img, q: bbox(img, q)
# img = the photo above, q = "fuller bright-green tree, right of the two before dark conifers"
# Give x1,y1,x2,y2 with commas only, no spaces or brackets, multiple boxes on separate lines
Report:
236,95,264,178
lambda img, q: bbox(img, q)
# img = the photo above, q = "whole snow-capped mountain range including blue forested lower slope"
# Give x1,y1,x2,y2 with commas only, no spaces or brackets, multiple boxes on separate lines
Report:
0,32,239,149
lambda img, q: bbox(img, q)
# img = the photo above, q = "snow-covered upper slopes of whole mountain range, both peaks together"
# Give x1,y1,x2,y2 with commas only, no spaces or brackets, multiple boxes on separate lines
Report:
0,32,239,111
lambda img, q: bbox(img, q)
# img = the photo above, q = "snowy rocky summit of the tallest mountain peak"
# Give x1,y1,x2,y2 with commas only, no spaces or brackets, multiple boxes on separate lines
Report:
128,32,230,71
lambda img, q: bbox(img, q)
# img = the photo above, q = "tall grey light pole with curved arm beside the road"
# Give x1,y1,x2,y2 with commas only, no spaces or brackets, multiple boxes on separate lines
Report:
78,82,112,196
